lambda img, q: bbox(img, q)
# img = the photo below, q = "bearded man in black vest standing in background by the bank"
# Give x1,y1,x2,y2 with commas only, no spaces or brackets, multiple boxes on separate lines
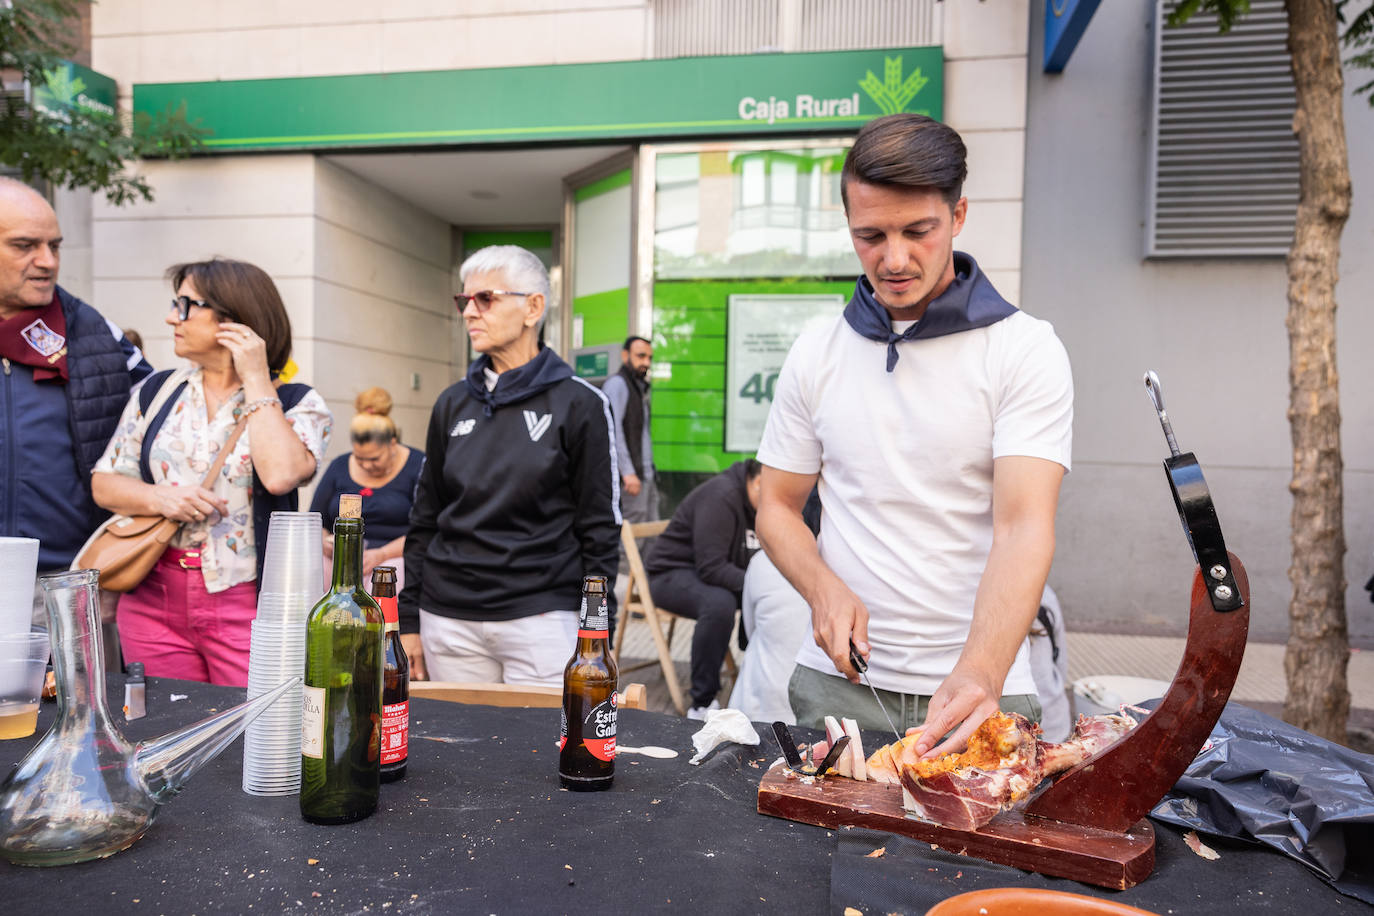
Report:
602,335,658,522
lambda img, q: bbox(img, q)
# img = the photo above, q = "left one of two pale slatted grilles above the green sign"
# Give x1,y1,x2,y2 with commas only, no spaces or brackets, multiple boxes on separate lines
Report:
654,0,782,58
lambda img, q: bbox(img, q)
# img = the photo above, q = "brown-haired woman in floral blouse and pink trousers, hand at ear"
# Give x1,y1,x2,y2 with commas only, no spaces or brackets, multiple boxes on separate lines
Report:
91,258,334,687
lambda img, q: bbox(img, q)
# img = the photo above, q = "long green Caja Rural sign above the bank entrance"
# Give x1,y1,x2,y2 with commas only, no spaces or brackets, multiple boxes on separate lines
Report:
133,47,944,151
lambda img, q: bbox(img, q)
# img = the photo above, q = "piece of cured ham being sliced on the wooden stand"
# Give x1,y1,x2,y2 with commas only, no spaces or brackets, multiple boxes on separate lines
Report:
870,713,1135,829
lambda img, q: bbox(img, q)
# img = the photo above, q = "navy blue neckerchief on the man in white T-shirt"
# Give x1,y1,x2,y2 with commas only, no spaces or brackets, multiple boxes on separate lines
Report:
845,251,1017,372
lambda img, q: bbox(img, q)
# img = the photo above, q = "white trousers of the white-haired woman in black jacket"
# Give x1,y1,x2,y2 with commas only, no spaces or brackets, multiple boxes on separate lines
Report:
420,608,577,687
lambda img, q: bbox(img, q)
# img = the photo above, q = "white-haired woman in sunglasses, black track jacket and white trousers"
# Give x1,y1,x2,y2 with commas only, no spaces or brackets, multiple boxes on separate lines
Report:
400,246,620,685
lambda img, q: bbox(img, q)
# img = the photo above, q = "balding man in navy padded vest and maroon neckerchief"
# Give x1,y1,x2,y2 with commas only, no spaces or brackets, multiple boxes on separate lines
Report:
0,179,153,634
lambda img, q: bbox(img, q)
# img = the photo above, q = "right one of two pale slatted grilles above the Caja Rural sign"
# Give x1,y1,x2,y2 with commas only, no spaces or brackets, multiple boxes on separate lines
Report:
797,0,940,51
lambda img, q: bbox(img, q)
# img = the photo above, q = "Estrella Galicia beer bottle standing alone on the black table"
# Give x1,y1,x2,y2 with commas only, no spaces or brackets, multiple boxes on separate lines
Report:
558,575,618,792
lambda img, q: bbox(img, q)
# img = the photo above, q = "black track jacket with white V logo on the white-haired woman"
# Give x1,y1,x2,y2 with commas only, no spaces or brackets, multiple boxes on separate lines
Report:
398,347,621,633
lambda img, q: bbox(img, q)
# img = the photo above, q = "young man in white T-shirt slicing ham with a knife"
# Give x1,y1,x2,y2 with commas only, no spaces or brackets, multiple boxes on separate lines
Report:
757,114,1073,758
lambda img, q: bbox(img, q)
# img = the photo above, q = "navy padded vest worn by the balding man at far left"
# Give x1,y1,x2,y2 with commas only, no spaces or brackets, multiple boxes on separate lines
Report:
0,287,153,570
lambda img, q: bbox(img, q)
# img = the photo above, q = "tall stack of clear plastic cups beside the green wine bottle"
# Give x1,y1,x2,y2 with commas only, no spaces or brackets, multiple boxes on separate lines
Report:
243,512,323,795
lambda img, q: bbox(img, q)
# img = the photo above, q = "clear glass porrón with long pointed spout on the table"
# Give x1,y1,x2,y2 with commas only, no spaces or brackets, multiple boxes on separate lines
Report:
0,570,300,865
